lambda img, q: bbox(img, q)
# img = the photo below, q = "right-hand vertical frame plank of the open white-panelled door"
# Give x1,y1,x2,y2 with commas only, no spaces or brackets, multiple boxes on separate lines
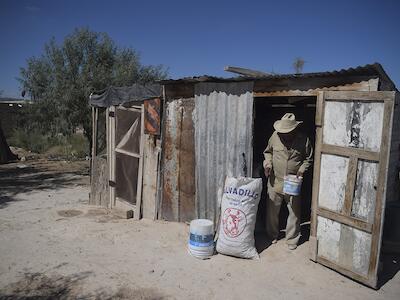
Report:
368,98,395,282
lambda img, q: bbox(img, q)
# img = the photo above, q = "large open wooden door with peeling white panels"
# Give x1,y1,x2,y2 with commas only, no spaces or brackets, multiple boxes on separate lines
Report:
310,91,395,288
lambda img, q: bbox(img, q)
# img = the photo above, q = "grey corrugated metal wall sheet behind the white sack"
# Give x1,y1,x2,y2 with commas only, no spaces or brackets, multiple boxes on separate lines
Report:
193,82,253,222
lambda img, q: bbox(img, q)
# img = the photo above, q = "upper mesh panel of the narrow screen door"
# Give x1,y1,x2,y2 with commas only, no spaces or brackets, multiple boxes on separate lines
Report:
115,109,141,154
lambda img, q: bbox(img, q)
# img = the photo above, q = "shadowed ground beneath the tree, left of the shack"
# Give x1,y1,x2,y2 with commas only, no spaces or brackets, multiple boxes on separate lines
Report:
0,160,89,209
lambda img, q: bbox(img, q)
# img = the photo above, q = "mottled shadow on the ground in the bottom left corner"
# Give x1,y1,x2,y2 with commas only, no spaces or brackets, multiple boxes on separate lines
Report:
0,272,169,300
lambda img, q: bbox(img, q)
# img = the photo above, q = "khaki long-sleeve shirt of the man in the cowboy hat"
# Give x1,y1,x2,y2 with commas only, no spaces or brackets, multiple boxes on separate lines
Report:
263,131,313,193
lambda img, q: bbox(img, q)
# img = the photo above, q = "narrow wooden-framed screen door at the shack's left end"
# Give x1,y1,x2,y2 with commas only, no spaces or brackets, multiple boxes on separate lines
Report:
109,106,144,219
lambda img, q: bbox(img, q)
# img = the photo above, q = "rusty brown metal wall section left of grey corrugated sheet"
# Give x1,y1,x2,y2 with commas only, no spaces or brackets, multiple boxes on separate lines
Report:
161,98,195,222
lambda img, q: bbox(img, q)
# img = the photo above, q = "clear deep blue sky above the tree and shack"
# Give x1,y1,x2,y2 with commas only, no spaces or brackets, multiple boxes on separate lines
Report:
0,0,400,97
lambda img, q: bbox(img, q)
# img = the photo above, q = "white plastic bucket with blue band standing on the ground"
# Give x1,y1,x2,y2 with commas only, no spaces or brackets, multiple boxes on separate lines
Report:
188,219,214,259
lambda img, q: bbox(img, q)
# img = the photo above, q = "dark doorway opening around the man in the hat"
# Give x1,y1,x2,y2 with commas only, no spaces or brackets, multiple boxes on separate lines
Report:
253,97,317,251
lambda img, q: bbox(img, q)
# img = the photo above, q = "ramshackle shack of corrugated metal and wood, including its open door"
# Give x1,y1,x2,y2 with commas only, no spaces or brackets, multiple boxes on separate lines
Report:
91,64,400,287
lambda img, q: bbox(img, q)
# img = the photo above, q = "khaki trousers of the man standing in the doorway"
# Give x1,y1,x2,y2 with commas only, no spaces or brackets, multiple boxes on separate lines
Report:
267,182,301,245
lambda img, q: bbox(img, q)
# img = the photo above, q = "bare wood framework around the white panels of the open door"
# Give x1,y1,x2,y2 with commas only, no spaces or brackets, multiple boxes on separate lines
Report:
310,91,395,288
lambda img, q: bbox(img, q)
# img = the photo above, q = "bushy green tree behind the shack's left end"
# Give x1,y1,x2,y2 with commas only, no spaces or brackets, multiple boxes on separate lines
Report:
19,28,167,142
